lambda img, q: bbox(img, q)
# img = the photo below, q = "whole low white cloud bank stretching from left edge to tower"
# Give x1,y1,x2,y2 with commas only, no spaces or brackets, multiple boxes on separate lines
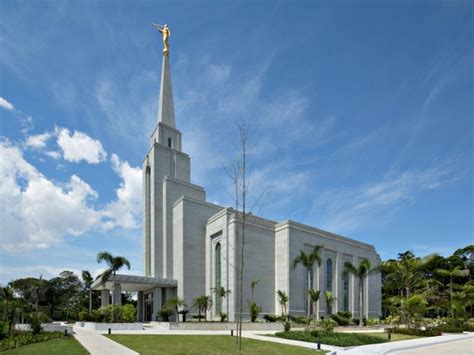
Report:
0,140,142,252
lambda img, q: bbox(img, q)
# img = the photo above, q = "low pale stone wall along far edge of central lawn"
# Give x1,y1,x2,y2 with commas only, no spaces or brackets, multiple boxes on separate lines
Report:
168,322,283,331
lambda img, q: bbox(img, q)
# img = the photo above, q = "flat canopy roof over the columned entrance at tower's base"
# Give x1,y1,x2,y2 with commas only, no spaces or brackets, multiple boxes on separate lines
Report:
92,275,178,292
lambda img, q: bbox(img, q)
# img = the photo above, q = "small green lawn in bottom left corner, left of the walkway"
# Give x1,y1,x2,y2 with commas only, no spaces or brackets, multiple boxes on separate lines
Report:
4,337,89,355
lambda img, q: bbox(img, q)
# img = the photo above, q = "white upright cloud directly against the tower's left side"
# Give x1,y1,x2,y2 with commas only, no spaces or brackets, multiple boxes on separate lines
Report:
104,154,142,229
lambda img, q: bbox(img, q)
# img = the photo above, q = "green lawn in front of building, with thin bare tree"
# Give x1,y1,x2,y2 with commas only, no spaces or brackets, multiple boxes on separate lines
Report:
109,335,324,355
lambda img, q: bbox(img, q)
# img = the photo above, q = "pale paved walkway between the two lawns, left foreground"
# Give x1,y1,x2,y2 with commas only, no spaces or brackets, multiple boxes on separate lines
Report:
73,327,139,355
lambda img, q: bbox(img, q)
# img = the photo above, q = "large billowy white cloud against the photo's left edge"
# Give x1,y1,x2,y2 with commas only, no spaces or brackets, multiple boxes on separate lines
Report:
0,141,100,250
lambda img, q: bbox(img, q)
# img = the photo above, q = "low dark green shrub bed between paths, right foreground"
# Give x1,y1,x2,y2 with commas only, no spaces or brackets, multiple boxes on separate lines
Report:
275,331,388,347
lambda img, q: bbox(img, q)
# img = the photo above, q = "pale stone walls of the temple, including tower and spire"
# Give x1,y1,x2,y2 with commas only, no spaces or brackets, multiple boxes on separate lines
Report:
96,56,381,321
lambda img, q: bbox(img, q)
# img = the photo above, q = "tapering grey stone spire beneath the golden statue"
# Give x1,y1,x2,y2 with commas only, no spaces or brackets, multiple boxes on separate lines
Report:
158,54,176,128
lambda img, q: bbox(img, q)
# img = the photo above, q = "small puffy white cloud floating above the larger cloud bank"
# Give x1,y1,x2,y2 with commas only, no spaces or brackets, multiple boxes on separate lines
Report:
56,128,107,164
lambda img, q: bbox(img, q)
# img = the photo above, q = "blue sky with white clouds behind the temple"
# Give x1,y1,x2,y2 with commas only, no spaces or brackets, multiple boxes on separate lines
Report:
0,0,474,283
